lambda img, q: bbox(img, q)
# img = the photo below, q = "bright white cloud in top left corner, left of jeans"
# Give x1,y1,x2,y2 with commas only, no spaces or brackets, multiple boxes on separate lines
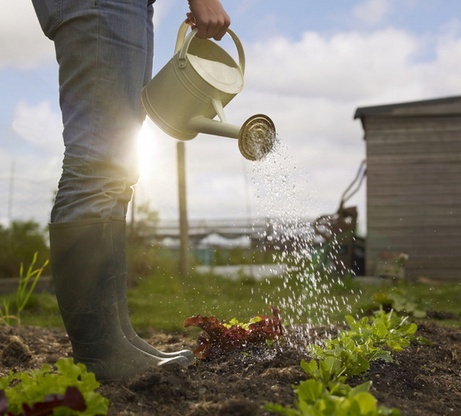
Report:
0,0,54,69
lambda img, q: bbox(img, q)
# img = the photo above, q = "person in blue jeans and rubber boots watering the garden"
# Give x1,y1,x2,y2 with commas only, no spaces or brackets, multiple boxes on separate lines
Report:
32,0,230,381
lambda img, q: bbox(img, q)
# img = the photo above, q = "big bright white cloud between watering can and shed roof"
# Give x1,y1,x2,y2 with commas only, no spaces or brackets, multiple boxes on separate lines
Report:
246,29,421,101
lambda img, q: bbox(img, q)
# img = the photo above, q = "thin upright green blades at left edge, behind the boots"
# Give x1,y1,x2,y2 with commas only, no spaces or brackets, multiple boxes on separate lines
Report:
0,252,48,325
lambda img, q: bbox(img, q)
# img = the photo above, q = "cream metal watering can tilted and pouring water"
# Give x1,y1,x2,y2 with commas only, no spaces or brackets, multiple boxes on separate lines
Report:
142,23,276,160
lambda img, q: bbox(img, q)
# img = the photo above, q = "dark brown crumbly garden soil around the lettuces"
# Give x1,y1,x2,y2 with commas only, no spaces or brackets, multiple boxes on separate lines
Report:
0,322,461,416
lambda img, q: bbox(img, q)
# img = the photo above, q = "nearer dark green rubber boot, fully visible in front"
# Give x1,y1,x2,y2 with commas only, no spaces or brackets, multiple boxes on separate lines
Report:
50,221,188,381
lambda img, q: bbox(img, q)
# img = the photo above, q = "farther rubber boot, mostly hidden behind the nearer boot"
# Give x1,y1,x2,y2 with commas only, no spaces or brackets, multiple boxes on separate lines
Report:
112,220,194,362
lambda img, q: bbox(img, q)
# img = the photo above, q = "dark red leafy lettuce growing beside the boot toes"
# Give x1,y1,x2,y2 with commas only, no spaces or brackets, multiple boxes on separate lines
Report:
184,306,283,360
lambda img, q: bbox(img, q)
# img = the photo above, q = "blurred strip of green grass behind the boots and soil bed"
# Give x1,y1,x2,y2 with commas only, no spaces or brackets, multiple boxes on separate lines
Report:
9,264,461,335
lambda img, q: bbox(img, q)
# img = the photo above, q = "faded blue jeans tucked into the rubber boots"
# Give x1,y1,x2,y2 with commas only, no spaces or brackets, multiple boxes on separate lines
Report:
32,0,153,223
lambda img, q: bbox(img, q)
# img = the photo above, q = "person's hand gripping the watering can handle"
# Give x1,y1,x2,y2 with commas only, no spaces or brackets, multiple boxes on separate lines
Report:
186,0,230,40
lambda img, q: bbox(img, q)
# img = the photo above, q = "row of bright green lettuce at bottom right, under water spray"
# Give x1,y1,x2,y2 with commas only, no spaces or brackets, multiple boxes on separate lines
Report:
266,310,417,416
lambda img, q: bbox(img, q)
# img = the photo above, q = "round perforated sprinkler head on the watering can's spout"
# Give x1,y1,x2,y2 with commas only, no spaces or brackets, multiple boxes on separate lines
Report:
238,114,276,161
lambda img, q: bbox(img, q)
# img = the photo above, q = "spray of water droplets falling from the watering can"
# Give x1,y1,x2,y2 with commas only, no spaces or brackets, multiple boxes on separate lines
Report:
248,140,360,346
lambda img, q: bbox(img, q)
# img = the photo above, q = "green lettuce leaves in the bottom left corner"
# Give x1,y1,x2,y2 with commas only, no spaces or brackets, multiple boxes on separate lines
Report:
0,358,109,416
